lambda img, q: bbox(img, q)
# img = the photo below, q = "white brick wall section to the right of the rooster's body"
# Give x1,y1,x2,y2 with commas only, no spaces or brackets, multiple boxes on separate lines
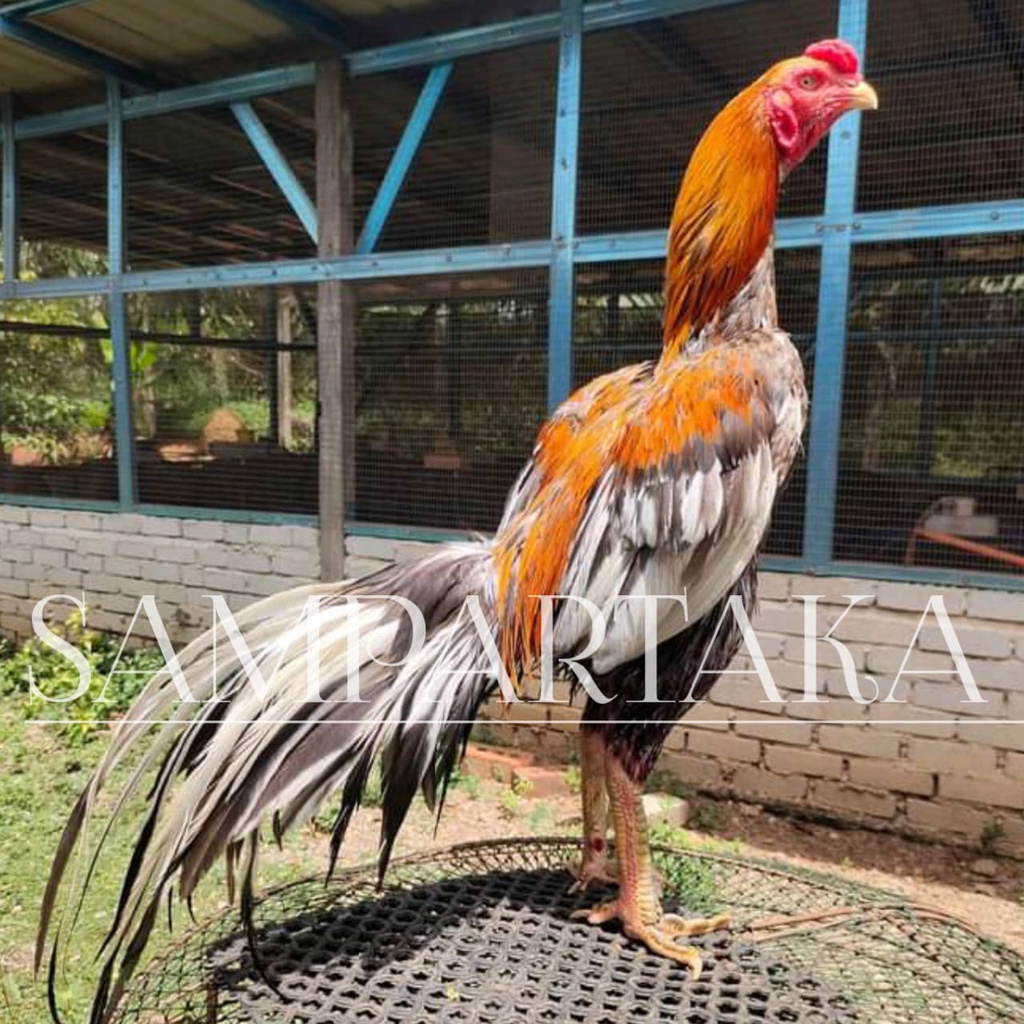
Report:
477,572,1024,856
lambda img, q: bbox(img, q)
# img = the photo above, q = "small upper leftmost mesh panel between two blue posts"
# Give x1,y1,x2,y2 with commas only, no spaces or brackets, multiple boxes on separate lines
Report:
17,128,108,280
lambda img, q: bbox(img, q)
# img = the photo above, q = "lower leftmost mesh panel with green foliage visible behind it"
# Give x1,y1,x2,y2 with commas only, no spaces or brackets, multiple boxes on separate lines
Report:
0,296,118,501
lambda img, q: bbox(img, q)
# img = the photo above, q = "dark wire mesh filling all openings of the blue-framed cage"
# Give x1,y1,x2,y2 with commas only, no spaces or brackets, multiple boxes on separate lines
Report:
2,0,1024,572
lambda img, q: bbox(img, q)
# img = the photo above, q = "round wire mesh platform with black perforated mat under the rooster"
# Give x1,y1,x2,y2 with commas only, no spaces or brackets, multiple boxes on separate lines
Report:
117,840,1024,1024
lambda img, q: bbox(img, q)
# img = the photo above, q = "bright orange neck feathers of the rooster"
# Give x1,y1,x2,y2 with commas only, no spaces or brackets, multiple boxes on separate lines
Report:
663,80,780,359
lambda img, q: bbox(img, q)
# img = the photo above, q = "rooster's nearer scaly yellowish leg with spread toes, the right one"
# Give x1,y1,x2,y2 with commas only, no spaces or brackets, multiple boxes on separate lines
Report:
574,753,729,981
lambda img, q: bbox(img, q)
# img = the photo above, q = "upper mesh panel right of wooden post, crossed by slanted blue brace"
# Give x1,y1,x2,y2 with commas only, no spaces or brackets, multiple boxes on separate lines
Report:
368,43,557,250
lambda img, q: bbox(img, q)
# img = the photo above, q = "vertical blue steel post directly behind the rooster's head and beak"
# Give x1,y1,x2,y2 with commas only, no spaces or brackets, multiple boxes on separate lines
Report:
804,0,867,569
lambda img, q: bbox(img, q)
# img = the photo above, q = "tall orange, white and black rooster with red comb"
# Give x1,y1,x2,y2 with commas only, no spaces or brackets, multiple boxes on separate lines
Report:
36,40,877,1022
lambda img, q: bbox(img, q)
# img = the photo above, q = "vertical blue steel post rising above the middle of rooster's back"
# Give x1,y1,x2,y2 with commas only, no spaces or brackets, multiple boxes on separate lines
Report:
548,0,583,410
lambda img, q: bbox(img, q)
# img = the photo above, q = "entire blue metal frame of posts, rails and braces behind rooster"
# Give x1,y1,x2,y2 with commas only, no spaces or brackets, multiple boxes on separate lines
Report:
0,0,1024,589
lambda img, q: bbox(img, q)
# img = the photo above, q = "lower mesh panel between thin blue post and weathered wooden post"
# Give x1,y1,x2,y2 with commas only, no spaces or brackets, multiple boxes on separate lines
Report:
130,288,317,514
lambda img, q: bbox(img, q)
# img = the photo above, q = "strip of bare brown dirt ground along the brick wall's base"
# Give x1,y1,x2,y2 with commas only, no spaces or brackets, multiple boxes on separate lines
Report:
314,779,1024,954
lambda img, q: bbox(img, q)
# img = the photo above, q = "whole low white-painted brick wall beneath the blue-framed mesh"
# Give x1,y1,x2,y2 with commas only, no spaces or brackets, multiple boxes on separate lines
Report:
0,507,1024,854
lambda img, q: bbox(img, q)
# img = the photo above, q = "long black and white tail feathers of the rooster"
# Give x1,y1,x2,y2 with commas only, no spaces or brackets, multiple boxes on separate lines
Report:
36,544,498,1024
